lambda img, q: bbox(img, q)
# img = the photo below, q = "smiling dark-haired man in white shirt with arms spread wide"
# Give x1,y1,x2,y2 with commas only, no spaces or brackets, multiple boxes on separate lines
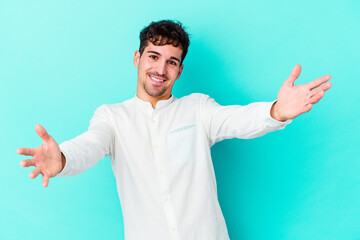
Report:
17,21,331,240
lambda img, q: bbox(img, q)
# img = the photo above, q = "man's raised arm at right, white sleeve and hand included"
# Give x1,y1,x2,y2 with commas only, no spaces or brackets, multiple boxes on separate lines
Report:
201,65,331,145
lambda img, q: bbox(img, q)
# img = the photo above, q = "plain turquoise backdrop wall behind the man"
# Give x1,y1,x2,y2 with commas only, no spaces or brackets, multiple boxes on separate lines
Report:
0,0,360,240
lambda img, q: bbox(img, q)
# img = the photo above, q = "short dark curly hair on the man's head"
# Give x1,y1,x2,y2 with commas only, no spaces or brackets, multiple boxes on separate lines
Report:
139,20,190,64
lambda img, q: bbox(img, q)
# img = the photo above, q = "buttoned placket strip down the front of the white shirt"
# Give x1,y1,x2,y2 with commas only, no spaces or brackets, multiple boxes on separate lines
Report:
150,109,180,240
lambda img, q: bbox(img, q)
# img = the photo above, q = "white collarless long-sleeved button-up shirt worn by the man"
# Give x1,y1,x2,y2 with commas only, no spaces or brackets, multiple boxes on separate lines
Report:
58,93,290,240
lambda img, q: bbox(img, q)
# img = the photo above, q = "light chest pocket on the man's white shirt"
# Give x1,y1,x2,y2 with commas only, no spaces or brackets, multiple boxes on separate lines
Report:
168,124,198,164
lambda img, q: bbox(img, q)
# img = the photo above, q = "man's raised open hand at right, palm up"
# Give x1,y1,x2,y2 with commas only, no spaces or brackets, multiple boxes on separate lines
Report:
270,64,331,121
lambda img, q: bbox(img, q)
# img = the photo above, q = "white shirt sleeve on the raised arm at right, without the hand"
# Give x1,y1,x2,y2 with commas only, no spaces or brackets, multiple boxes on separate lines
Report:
201,95,291,146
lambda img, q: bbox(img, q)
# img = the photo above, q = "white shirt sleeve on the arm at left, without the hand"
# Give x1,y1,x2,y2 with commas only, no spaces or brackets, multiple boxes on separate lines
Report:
57,105,114,177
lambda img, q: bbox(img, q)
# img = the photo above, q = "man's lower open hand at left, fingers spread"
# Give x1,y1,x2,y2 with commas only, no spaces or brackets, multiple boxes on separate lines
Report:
16,125,66,187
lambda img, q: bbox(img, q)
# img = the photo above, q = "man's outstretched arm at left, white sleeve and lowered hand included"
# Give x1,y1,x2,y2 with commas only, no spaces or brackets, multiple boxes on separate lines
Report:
17,105,115,187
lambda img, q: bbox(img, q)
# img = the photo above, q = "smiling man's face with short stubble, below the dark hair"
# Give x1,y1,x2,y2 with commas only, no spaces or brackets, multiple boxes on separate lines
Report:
134,42,184,101
